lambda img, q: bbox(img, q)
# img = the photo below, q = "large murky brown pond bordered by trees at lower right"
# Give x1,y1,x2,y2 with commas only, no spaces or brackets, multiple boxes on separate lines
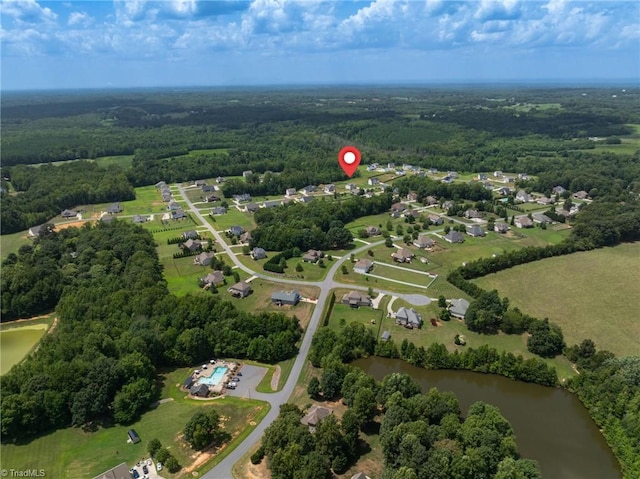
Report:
352,357,622,479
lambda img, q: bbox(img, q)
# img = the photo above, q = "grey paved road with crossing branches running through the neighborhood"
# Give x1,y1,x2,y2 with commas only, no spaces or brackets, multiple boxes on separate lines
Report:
178,185,430,479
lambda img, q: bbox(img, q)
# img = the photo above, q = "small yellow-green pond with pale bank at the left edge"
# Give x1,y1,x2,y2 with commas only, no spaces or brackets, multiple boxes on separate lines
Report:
0,315,53,375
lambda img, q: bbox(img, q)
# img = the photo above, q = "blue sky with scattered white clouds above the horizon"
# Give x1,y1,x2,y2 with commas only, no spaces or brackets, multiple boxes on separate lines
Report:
0,0,640,90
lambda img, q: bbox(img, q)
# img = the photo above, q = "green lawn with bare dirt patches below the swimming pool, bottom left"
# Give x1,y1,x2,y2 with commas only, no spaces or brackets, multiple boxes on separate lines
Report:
0,369,268,479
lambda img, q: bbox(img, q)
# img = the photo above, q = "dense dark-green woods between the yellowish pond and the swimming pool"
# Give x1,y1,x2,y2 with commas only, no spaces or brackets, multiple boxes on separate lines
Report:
0,221,301,441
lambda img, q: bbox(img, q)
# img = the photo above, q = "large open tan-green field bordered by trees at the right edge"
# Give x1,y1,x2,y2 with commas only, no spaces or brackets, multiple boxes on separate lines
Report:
475,243,640,355
